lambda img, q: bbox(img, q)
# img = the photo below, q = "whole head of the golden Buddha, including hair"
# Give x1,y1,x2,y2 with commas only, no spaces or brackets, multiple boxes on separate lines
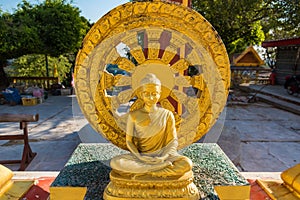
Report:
141,73,161,106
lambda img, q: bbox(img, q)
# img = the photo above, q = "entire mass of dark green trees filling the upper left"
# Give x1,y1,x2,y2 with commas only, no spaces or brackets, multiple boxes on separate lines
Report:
0,0,89,88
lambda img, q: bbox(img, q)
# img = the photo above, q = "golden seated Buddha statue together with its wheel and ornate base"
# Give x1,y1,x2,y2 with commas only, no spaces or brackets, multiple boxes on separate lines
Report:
75,0,230,200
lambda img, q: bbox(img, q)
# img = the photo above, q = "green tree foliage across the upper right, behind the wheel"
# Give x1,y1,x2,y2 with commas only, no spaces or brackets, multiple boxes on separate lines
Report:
130,0,300,54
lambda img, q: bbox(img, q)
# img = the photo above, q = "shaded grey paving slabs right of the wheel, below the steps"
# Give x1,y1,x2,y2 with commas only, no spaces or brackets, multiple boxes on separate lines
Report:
218,103,300,172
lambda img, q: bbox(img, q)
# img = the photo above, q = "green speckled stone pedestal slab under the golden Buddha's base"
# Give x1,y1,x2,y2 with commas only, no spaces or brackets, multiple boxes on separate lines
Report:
50,144,250,200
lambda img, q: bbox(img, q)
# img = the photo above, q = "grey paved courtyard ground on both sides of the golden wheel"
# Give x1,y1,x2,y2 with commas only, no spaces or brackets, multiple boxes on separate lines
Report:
0,86,300,172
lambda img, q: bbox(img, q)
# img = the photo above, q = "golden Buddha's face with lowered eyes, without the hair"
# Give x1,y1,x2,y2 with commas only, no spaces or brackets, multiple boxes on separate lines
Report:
142,84,161,106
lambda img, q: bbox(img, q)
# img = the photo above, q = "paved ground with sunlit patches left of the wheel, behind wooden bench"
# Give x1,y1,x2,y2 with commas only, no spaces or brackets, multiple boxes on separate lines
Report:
0,96,83,171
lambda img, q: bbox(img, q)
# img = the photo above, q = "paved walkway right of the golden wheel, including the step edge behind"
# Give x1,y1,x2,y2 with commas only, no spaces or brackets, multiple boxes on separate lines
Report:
217,85,300,172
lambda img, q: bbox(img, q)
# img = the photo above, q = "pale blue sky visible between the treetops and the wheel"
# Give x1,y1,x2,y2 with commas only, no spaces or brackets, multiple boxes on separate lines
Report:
0,0,129,22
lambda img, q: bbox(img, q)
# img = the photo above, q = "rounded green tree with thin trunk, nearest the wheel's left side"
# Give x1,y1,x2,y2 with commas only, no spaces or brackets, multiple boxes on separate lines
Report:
19,0,89,76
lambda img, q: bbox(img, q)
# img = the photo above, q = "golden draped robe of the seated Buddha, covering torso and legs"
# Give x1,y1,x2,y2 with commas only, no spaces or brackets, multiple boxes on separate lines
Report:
111,108,191,176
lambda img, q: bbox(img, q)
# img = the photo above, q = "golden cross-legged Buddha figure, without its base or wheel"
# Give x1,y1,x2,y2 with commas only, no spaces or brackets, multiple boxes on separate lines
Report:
111,73,192,178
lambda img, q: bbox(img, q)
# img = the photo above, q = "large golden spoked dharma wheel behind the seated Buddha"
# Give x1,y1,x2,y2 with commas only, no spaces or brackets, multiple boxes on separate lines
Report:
75,1,230,149
